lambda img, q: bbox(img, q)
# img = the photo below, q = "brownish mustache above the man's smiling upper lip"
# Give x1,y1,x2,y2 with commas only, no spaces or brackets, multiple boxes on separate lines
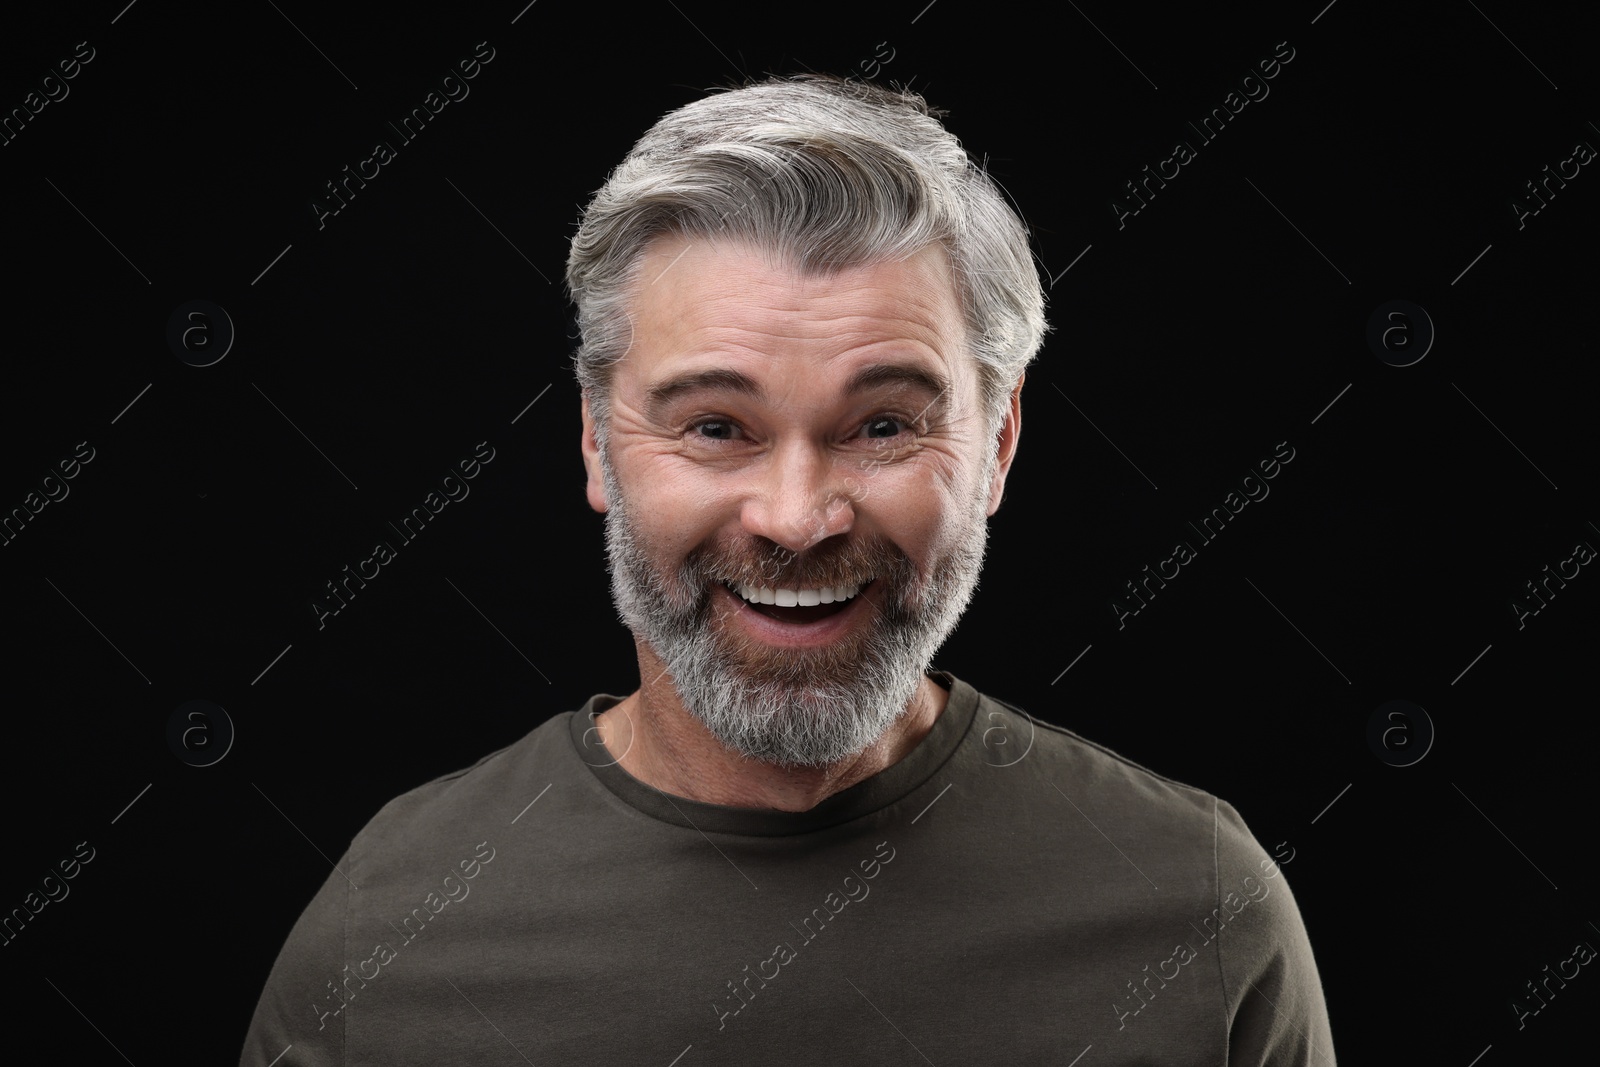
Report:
685,537,914,589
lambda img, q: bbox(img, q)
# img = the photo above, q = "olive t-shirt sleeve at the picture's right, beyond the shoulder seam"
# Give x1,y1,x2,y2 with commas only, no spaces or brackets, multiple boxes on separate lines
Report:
1216,800,1334,1067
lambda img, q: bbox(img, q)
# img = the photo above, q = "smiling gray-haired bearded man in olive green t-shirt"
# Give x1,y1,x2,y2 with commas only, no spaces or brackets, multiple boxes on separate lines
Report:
243,77,1334,1067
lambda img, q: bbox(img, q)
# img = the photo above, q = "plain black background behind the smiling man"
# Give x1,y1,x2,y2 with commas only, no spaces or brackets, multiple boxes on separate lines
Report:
0,0,1600,1067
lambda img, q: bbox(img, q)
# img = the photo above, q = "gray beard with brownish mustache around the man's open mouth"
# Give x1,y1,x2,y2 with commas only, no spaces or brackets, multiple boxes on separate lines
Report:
600,446,994,768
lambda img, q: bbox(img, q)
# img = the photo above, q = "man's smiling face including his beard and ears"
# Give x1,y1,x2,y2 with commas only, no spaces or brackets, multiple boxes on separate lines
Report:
584,237,1019,766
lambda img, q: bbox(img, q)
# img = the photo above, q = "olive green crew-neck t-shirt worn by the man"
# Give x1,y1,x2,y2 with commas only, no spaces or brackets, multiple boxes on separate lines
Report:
240,672,1334,1067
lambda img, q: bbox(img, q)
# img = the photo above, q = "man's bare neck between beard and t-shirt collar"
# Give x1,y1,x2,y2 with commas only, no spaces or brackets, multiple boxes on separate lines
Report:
595,641,949,811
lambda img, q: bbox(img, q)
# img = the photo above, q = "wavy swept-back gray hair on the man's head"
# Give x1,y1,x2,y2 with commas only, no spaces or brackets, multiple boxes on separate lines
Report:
566,75,1050,445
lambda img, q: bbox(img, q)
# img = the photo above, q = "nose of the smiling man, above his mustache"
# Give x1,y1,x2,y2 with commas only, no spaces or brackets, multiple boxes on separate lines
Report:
741,443,856,552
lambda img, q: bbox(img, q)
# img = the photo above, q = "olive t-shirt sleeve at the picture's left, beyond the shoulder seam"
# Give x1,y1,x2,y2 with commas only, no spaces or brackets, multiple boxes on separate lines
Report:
238,857,350,1067
